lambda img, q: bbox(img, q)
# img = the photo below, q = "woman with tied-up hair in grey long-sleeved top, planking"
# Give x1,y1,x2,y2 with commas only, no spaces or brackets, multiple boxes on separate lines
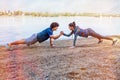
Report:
61,22,117,48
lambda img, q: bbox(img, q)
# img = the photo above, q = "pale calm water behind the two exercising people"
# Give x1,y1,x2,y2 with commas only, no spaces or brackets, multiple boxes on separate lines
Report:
0,16,120,44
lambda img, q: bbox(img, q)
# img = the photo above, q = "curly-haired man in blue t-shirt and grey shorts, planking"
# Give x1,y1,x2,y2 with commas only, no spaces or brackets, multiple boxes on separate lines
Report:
6,22,62,50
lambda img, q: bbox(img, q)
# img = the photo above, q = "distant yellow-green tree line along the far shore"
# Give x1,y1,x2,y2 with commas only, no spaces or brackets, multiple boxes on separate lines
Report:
0,10,120,17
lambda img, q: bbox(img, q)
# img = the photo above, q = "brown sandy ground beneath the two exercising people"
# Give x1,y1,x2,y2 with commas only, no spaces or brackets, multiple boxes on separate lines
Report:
0,38,120,80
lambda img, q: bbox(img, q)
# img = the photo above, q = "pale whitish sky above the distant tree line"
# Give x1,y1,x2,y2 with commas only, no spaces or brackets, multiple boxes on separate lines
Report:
0,0,120,13
